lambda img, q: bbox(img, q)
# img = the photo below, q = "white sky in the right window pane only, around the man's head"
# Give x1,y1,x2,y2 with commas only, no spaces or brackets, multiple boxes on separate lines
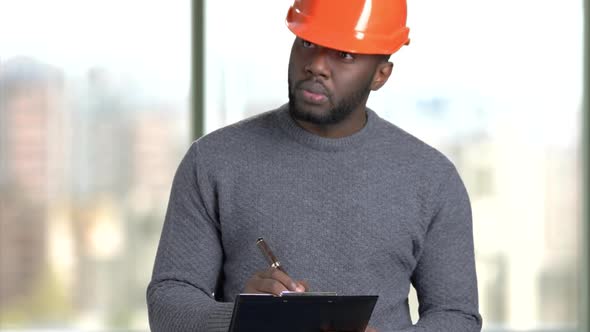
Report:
206,0,583,146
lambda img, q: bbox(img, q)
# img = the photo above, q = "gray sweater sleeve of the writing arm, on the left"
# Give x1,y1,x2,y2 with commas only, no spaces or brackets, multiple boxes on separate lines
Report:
147,143,233,332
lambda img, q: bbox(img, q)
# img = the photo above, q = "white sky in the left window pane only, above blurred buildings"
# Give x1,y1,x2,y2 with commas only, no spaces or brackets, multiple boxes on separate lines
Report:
0,0,191,100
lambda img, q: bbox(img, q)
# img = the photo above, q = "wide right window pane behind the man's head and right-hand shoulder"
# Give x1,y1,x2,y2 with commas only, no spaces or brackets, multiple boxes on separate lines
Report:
205,0,583,331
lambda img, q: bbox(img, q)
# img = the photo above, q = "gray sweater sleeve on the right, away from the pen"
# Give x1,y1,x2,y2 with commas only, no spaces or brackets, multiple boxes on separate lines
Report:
404,167,482,332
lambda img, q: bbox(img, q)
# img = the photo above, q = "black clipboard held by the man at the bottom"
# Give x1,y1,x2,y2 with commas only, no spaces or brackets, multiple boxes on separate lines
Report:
229,293,378,332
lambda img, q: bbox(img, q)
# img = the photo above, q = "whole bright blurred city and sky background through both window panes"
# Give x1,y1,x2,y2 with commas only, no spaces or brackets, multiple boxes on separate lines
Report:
0,0,583,331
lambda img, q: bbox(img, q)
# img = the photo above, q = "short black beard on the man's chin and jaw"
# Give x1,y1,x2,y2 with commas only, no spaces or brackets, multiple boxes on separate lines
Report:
288,77,371,125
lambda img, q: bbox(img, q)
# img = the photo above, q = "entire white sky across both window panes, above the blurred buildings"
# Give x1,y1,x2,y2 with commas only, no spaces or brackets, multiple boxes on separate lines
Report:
0,0,583,144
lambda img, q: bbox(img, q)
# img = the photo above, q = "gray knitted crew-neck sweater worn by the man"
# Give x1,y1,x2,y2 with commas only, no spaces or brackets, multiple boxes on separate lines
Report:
147,106,481,332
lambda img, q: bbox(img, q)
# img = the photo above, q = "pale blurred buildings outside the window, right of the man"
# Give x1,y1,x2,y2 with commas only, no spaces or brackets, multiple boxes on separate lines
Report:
449,128,581,329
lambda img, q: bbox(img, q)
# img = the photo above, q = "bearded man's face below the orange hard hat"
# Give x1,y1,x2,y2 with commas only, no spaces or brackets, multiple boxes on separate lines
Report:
289,38,388,125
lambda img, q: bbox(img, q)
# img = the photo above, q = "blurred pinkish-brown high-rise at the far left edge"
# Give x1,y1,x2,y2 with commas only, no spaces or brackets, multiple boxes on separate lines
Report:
0,57,64,311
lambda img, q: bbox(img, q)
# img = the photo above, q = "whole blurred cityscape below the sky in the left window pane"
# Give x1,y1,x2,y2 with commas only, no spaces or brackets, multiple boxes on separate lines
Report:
0,58,189,329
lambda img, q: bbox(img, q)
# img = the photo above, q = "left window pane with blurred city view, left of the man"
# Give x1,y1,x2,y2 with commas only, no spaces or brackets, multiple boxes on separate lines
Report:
0,0,191,331
